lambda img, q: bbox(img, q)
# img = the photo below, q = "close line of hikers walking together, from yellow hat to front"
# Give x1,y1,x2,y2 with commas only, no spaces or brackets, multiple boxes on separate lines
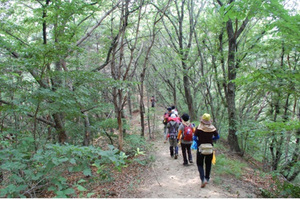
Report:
163,106,219,188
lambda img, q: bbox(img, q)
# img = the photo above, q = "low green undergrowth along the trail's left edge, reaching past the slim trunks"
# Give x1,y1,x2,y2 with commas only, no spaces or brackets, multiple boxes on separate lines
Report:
0,132,151,198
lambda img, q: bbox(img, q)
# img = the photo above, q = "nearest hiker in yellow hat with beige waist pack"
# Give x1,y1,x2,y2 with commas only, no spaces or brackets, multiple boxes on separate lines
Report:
193,113,219,188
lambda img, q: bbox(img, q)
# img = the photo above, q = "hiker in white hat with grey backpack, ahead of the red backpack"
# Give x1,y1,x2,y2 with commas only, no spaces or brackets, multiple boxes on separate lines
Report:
164,114,179,159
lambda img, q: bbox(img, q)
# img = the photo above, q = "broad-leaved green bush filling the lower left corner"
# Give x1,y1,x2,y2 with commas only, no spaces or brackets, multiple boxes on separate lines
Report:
0,139,127,197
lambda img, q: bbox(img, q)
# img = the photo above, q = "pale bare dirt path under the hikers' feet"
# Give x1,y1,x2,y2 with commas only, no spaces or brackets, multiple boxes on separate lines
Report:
135,131,236,198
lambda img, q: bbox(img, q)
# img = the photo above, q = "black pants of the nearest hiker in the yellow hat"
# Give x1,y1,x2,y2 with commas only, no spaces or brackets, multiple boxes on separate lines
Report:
197,150,213,182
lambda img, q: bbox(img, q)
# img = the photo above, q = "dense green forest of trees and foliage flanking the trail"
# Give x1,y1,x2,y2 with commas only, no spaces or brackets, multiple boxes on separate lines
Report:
0,0,300,197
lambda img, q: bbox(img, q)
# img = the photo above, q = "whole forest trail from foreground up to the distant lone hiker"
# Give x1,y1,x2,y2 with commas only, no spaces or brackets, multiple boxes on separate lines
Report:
126,105,257,198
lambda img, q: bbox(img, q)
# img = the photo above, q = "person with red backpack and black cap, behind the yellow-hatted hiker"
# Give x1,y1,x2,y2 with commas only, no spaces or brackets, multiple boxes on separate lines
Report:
177,113,195,166
